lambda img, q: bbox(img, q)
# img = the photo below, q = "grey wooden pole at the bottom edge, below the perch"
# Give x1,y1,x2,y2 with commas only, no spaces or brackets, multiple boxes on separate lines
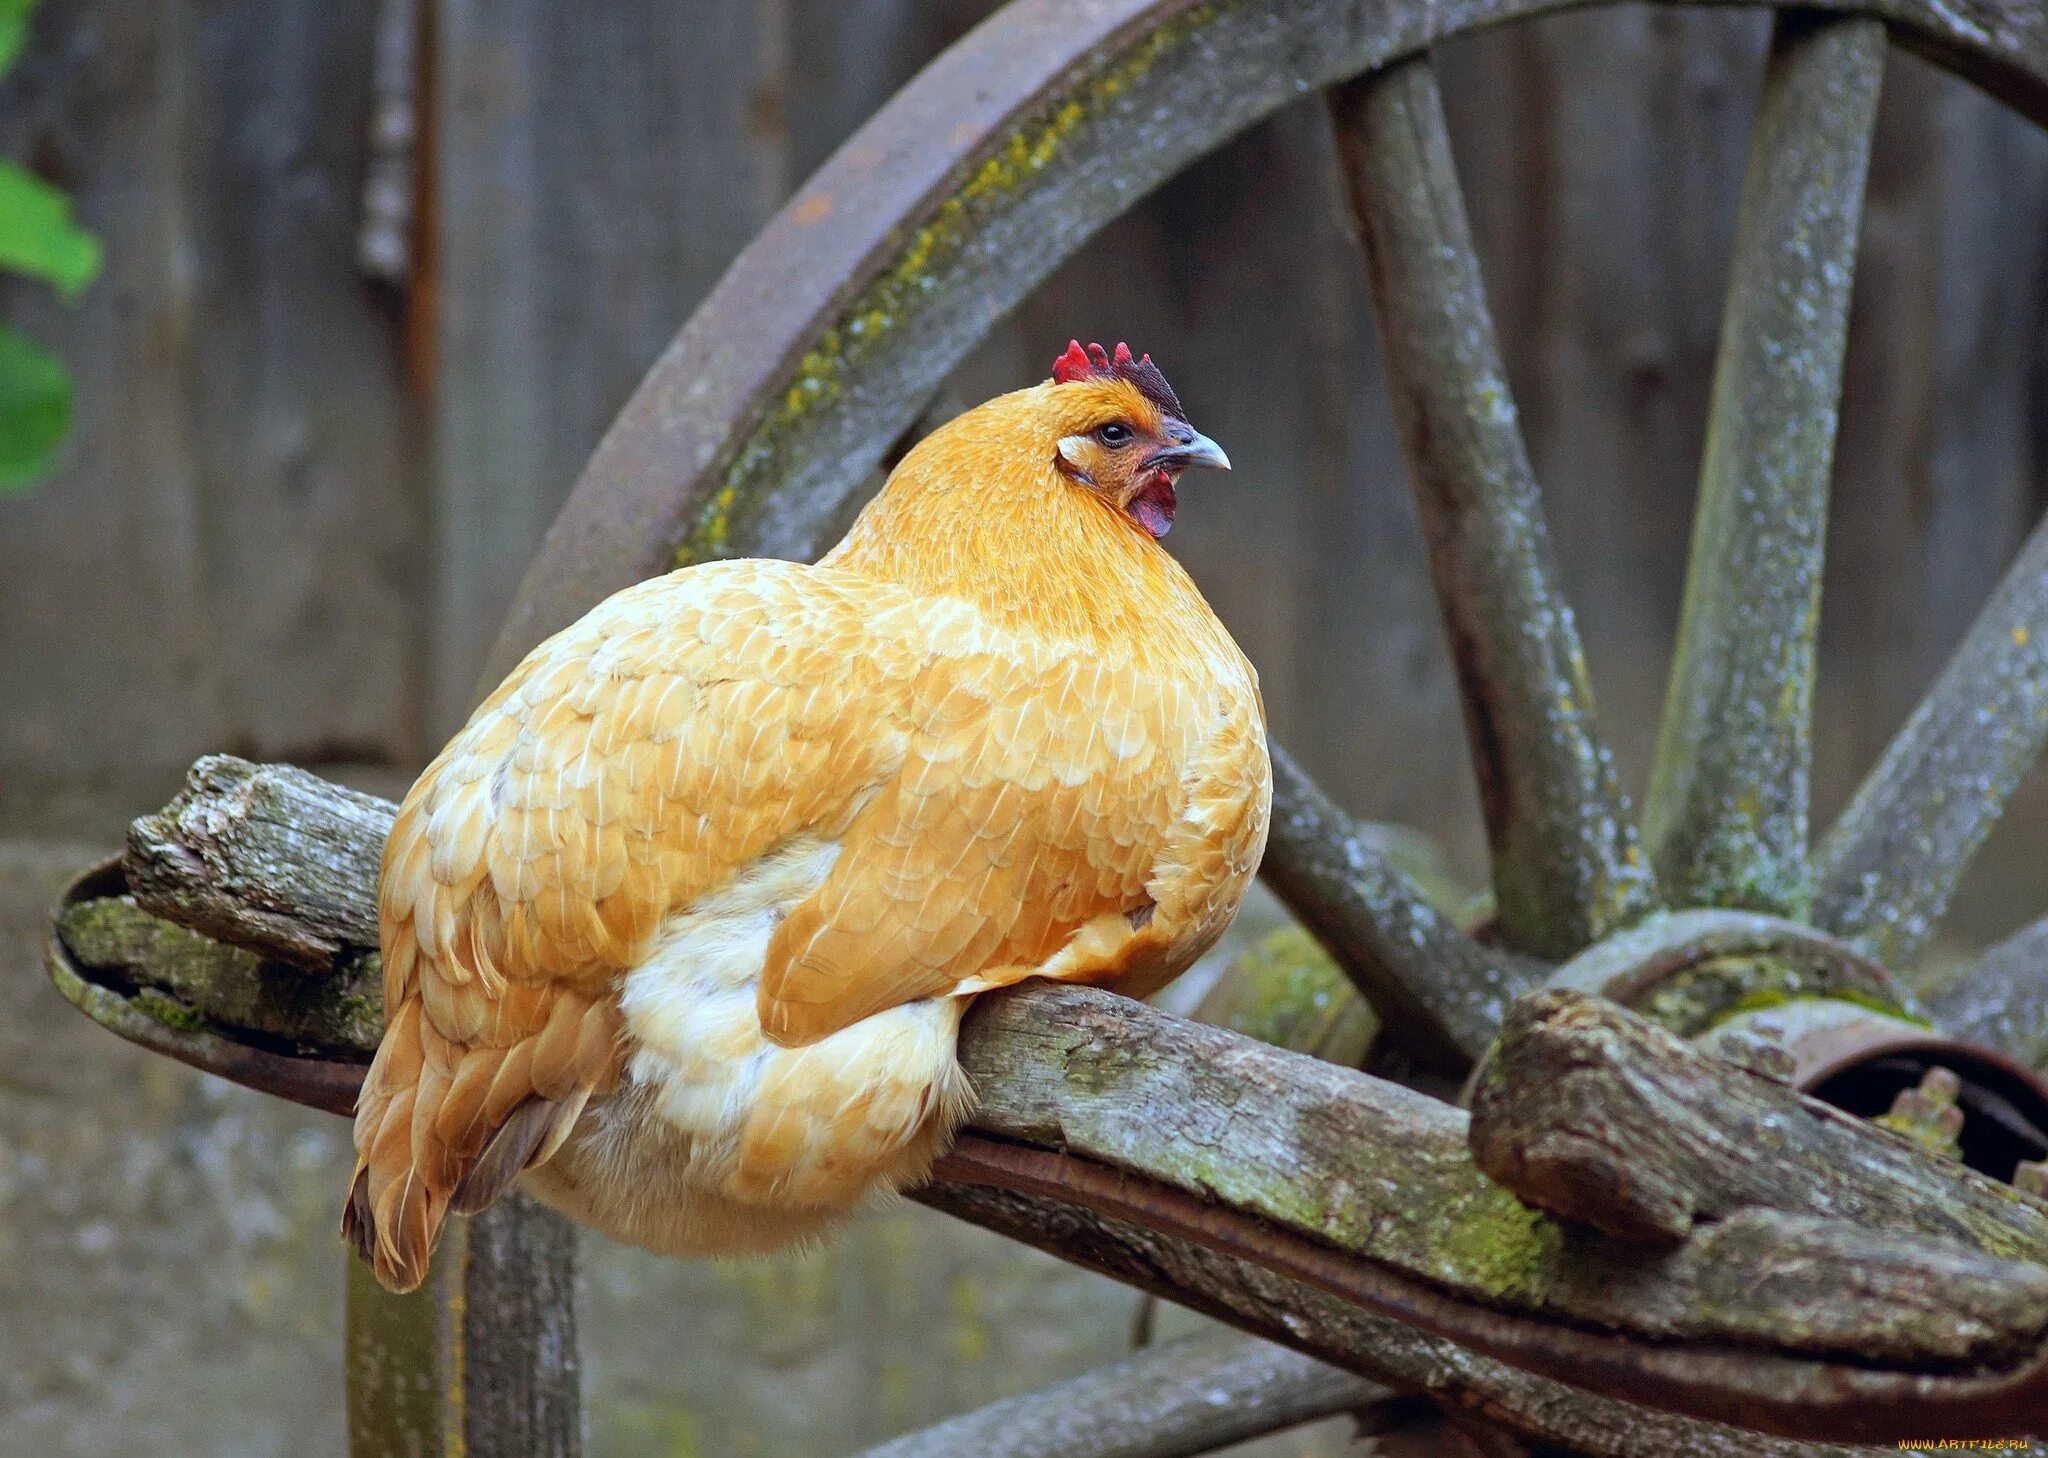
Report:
860,1335,1397,1458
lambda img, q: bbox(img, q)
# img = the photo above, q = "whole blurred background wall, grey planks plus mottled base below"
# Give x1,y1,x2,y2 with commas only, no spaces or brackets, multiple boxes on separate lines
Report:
0,0,2048,1454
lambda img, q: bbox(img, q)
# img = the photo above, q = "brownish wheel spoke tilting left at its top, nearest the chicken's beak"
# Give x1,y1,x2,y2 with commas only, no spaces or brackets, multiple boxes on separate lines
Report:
1331,59,1657,958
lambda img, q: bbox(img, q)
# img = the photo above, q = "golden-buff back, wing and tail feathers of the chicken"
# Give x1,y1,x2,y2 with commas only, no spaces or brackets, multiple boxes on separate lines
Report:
344,543,1266,1288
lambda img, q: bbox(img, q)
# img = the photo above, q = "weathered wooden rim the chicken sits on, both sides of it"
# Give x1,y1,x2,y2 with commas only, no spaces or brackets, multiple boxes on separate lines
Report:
39,758,2048,1452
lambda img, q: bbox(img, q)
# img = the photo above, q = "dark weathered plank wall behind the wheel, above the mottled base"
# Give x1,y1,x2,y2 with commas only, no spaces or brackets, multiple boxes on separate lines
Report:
0,0,2048,926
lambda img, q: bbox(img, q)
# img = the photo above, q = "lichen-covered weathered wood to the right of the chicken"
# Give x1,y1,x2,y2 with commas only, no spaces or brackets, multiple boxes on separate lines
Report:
961,987,2048,1362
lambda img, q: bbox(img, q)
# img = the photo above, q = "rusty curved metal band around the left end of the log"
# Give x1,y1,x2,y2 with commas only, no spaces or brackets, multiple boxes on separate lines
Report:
43,856,367,1116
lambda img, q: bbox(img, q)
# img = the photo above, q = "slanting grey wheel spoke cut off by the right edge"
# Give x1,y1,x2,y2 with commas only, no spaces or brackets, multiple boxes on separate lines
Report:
1815,520,2048,967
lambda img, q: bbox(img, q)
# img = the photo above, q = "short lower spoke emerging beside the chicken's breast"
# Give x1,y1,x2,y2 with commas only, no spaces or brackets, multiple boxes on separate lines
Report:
1260,745,1546,1069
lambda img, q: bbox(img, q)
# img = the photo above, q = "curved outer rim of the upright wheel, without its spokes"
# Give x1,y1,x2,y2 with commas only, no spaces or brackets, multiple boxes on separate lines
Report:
489,0,2048,680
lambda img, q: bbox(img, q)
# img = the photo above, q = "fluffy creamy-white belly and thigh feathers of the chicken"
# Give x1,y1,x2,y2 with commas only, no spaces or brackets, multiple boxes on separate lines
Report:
526,838,969,1253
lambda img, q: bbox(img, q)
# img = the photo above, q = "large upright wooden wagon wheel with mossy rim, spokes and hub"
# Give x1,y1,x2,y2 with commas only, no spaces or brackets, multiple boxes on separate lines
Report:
492,0,2048,1441
